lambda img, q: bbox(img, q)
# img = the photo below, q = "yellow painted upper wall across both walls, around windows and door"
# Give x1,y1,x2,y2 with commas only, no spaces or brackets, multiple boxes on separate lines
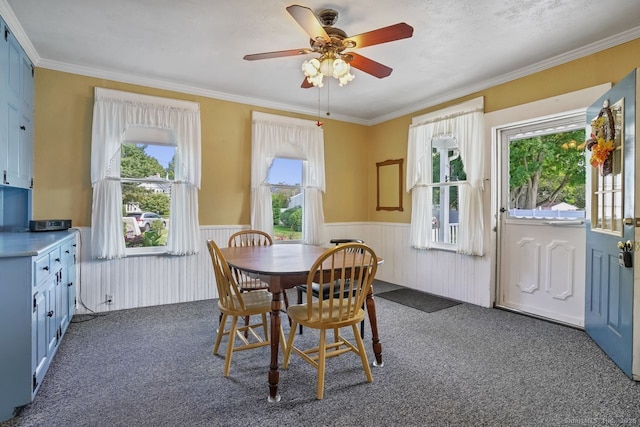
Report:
33,39,640,226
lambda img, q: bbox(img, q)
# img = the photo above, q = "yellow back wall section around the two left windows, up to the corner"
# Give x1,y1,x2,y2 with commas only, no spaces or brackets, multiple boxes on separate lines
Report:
33,68,375,226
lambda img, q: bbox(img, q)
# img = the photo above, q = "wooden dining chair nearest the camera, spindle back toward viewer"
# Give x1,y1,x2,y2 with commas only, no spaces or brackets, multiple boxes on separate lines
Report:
282,243,378,399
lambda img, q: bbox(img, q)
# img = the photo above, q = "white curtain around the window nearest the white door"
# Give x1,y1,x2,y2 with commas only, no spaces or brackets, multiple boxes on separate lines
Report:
406,98,485,255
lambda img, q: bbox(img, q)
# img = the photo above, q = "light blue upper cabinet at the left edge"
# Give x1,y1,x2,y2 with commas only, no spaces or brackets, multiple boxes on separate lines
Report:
0,15,34,189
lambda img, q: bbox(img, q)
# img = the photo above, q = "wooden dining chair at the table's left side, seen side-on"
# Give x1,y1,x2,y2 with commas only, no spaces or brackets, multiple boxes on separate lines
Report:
207,240,285,377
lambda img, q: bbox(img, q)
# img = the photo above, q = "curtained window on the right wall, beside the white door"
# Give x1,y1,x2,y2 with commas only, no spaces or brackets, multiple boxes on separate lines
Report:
406,98,486,256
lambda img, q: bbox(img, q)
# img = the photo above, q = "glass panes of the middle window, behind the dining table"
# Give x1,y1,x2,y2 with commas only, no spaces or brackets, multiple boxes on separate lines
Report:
267,158,304,240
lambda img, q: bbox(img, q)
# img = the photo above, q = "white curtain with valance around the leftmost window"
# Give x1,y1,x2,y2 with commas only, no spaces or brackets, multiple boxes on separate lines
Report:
91,88,201,259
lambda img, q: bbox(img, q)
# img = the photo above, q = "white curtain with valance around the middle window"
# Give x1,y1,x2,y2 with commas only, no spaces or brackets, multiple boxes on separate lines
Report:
251,112,325,245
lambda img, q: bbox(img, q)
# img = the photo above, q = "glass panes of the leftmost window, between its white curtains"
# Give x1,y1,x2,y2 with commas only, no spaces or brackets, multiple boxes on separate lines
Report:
120,143,176,249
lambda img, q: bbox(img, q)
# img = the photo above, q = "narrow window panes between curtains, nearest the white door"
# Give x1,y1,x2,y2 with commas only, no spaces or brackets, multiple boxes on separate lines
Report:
431,137,467,247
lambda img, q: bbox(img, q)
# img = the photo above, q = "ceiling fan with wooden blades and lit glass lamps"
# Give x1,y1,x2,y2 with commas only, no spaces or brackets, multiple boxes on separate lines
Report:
244,5,413,88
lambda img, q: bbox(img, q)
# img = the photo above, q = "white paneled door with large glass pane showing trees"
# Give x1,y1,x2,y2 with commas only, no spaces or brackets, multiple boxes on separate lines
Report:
496,111,586,327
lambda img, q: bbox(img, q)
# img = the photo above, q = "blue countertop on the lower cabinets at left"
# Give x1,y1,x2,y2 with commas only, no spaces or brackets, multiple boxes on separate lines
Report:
0,229,78,258
